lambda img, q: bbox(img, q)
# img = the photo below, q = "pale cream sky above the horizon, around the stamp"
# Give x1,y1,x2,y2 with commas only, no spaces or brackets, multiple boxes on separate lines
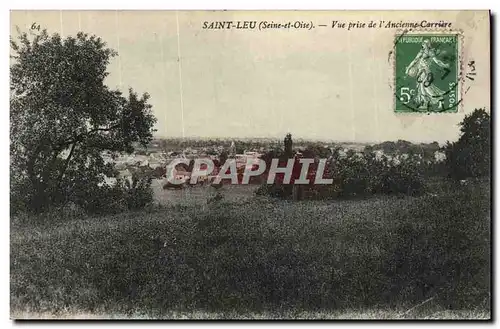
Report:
11,11,490,142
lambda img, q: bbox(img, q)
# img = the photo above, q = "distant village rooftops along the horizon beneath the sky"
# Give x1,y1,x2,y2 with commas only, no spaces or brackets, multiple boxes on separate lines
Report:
99,139,445,185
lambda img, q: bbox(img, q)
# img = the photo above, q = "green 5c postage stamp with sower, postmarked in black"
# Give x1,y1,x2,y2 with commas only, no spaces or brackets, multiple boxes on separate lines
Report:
394,32,461,113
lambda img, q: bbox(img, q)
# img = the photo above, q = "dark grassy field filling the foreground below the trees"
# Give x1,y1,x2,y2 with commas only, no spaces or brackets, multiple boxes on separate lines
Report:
11,179,490,319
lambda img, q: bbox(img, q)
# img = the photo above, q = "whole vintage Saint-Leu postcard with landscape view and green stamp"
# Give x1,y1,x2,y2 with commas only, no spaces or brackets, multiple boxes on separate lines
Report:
10,10,492,320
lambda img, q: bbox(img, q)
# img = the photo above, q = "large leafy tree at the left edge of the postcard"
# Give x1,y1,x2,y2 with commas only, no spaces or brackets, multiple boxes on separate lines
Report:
10,30,156,211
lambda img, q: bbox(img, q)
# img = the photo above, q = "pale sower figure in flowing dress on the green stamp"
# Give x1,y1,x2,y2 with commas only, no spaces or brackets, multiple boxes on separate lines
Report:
405,40,450,109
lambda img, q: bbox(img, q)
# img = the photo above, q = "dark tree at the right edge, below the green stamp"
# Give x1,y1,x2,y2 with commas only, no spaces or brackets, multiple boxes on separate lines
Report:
444,109,491,179
